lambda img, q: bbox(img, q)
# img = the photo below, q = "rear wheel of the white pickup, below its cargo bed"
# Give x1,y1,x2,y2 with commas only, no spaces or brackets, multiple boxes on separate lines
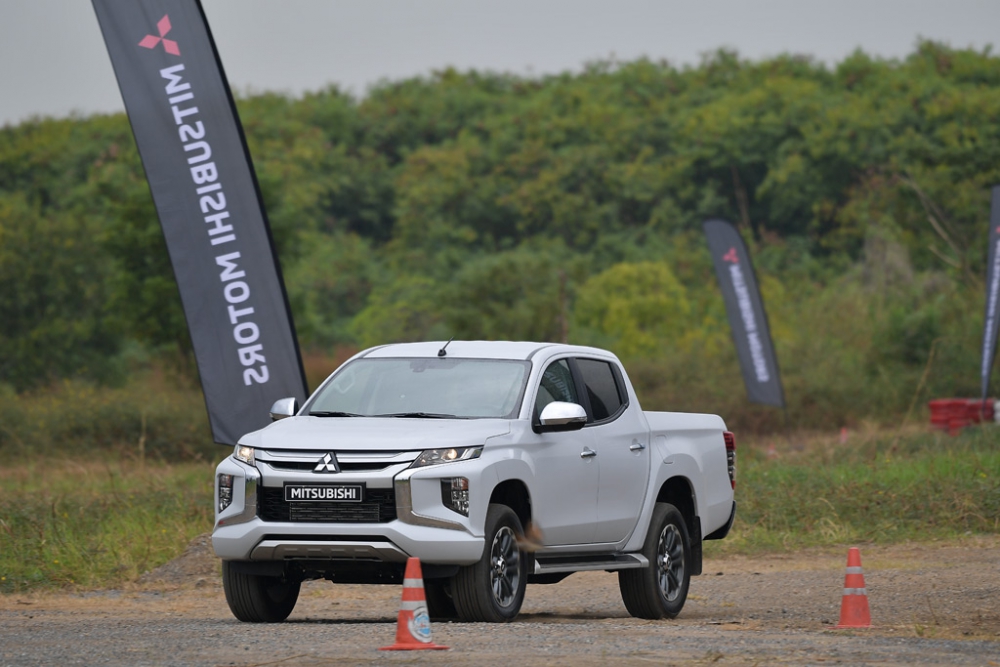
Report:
618,503,692,620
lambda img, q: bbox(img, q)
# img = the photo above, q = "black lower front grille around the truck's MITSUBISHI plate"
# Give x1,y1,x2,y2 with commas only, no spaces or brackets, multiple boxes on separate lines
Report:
257,486,396,523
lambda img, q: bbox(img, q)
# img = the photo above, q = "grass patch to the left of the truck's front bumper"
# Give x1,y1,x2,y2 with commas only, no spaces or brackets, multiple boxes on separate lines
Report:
0,459,213,593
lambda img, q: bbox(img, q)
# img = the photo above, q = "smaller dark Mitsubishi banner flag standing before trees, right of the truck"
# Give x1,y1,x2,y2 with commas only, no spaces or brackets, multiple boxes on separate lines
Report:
704,220,785,407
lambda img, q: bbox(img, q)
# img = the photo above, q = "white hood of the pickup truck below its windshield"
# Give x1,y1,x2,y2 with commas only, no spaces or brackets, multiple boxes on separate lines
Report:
240,417,510,451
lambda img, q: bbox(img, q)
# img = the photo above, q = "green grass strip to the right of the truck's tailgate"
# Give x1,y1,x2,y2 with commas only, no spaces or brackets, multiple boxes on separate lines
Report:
706,426,1000,553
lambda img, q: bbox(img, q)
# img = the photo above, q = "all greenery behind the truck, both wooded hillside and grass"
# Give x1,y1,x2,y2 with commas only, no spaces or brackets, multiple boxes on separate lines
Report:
0,42,1000,591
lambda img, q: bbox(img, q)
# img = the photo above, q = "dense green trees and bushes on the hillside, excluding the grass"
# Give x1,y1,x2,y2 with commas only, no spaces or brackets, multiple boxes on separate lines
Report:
0,42,1000,430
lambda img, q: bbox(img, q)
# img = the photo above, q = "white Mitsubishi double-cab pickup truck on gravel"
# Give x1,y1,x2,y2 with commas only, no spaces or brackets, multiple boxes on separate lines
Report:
212,341,736,622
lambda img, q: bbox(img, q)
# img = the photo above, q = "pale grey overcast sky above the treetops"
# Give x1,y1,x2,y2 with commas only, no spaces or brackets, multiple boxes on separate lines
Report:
0,0,1000,124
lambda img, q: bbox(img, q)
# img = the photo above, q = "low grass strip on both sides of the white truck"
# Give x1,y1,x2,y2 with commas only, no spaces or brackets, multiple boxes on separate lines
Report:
0,425,1000,593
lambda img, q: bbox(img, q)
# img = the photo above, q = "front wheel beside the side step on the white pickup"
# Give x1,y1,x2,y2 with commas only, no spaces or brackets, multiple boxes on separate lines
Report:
452,505,528,623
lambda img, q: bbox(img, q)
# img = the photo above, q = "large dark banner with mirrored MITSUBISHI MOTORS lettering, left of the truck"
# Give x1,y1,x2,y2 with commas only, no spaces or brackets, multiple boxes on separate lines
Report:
93,0,306,444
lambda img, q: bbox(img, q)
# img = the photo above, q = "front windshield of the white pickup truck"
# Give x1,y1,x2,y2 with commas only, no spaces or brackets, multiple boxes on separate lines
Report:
304,358,530,419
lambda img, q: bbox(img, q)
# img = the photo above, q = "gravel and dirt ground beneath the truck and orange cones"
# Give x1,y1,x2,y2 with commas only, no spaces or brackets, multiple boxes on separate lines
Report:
0,538,1000,667
